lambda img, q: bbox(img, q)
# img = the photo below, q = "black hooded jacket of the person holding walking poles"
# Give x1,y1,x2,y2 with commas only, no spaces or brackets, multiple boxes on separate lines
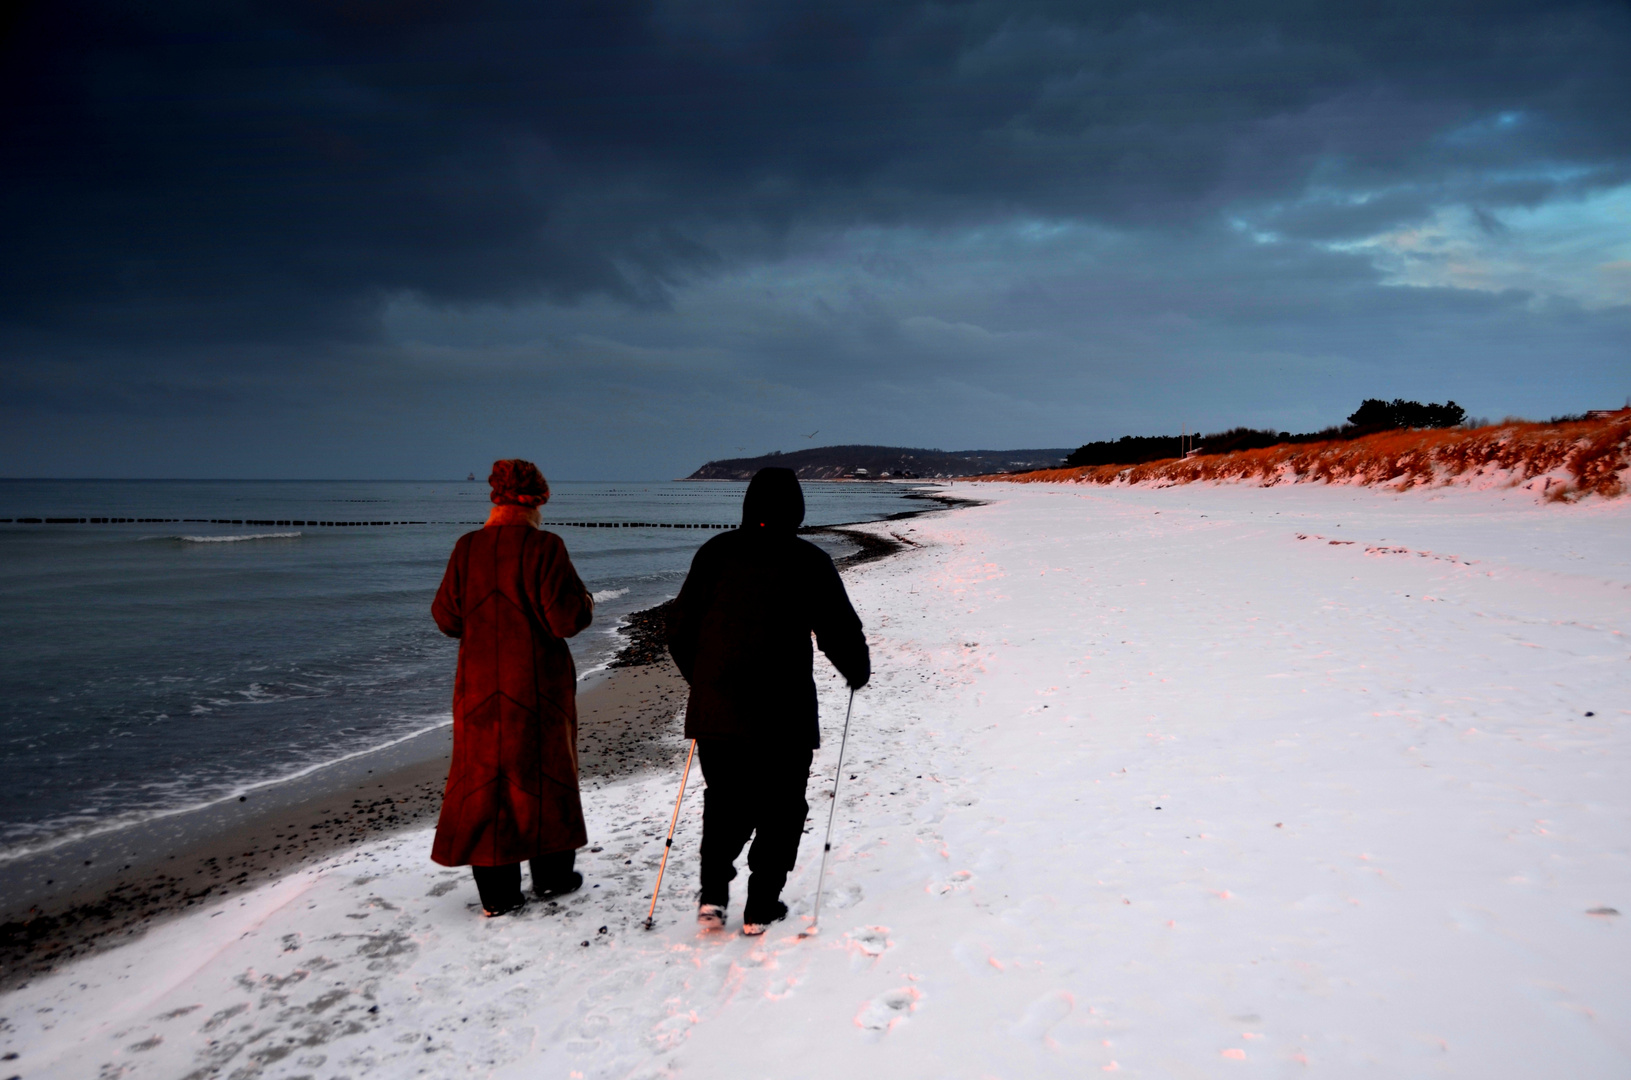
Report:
667,468,873,747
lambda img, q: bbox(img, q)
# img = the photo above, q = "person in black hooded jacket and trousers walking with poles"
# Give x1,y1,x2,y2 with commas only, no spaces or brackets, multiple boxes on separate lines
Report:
667,468,871,933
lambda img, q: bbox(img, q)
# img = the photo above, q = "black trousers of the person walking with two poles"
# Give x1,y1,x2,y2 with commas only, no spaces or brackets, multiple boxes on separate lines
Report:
696,739,814,907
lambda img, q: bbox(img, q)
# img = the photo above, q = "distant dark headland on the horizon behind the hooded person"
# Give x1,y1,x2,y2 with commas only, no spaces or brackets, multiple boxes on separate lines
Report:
687,445,1070,480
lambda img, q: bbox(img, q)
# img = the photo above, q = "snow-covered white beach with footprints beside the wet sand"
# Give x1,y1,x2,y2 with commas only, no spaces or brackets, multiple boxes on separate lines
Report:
0,486,1631,1080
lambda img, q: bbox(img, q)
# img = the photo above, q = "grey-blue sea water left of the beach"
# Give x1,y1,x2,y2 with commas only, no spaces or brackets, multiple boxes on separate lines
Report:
0,481,922,856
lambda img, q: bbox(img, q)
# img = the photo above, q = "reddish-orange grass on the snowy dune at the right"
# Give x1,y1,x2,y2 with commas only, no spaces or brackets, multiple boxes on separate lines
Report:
983,408,1631,501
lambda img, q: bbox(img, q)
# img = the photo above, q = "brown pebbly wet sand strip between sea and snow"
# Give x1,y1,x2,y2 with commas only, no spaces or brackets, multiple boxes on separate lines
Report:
0,657,685,990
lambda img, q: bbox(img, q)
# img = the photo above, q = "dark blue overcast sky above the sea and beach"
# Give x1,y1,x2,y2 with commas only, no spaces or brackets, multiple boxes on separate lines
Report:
0,0,1631,480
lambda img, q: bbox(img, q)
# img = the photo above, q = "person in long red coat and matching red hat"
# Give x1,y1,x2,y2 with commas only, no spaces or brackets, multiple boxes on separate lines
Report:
431,458,594,915
